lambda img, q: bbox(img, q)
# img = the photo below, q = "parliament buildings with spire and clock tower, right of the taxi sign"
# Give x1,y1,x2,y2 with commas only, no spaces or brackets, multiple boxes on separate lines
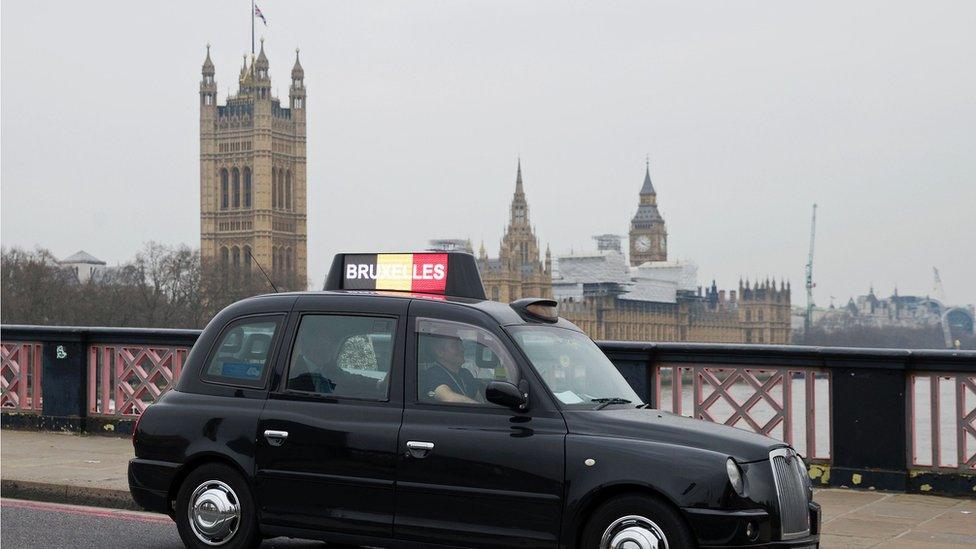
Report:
466,161,790,344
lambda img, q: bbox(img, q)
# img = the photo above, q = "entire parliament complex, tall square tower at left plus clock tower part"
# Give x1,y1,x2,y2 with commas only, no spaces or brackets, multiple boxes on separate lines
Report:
199,40,790,343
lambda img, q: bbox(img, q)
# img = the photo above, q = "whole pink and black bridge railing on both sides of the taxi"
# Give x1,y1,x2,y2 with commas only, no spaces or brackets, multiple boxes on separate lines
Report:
0,326,976,495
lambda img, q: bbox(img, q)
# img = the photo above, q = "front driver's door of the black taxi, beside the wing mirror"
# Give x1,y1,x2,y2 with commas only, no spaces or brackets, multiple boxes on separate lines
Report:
394,300,567,547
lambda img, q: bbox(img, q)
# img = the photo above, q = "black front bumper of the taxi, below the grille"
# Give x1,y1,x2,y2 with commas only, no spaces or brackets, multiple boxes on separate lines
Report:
681,502,820,549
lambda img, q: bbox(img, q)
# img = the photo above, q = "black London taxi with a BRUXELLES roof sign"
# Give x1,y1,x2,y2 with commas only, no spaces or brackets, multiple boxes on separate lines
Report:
129,253,820,549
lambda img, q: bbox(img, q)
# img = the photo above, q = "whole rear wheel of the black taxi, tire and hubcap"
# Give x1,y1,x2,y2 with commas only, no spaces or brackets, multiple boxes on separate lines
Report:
174,463,261,549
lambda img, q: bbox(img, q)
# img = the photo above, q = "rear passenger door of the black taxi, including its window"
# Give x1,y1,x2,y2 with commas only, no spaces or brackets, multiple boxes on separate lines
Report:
255,294,409,538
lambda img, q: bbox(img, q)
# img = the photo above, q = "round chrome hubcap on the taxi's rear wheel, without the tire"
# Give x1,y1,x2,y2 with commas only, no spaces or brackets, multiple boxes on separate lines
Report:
187,480,241,545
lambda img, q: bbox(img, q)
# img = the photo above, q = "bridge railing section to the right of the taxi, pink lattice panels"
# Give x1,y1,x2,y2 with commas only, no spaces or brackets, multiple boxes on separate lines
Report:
599,342,976,495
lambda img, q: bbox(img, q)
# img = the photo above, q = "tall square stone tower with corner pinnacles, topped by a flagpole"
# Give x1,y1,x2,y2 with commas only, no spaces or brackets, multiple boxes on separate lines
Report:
200,40,307,289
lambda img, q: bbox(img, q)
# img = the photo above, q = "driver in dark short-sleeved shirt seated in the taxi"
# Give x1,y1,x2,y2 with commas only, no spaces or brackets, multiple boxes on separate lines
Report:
420,335,480,404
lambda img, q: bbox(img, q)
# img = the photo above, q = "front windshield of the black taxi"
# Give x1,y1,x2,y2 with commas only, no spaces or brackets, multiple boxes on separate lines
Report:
509,326,644,409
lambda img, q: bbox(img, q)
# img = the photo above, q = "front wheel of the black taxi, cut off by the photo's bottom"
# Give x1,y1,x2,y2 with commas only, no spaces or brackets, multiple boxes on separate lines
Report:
579,494,697,549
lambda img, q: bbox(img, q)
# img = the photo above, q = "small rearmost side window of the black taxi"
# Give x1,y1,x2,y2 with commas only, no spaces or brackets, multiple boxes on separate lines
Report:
203,317,280,387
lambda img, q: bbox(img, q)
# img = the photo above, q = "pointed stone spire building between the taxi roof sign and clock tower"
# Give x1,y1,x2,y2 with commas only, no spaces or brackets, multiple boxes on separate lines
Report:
477,160,552,302
